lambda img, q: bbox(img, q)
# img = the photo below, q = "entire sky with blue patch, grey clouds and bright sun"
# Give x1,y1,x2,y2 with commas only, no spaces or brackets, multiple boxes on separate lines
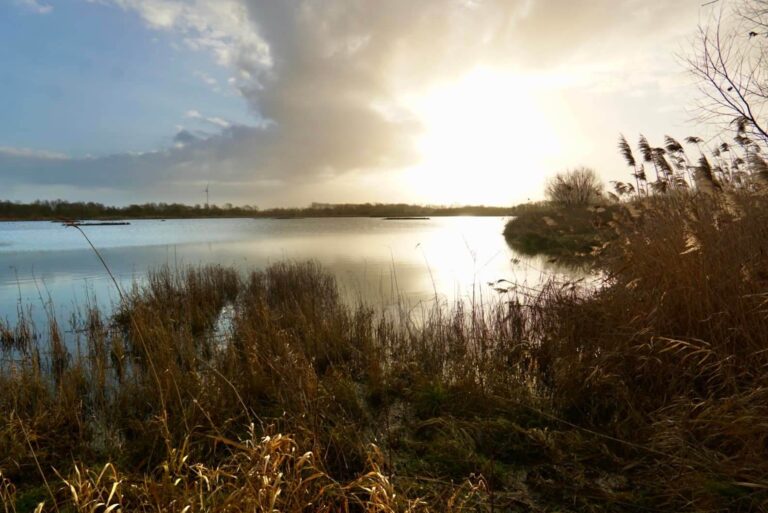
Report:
0,0,711,207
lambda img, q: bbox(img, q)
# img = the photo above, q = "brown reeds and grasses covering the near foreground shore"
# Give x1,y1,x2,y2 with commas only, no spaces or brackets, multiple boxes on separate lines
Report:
0,193,768,512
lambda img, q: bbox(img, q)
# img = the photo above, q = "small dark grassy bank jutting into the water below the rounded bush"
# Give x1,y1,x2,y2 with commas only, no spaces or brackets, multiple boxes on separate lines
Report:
504,203,620,260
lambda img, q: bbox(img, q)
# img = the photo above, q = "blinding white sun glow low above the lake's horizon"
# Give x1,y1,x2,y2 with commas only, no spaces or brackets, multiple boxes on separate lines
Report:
407,70,562,205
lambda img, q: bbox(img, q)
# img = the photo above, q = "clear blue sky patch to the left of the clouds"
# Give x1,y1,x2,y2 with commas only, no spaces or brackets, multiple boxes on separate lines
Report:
0,0,254,157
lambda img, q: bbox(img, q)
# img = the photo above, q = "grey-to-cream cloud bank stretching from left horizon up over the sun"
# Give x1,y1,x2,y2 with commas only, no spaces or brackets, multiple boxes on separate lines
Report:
0,0,695,204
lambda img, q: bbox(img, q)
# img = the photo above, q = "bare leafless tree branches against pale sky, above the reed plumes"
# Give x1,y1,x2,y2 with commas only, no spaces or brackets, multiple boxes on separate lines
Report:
687,0,768,143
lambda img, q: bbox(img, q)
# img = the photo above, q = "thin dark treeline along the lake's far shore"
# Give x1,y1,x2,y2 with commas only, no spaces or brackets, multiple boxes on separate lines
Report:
0,200,514,220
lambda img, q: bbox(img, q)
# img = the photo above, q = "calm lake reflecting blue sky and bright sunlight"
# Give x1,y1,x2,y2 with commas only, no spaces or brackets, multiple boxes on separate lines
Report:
0,217,563,323
